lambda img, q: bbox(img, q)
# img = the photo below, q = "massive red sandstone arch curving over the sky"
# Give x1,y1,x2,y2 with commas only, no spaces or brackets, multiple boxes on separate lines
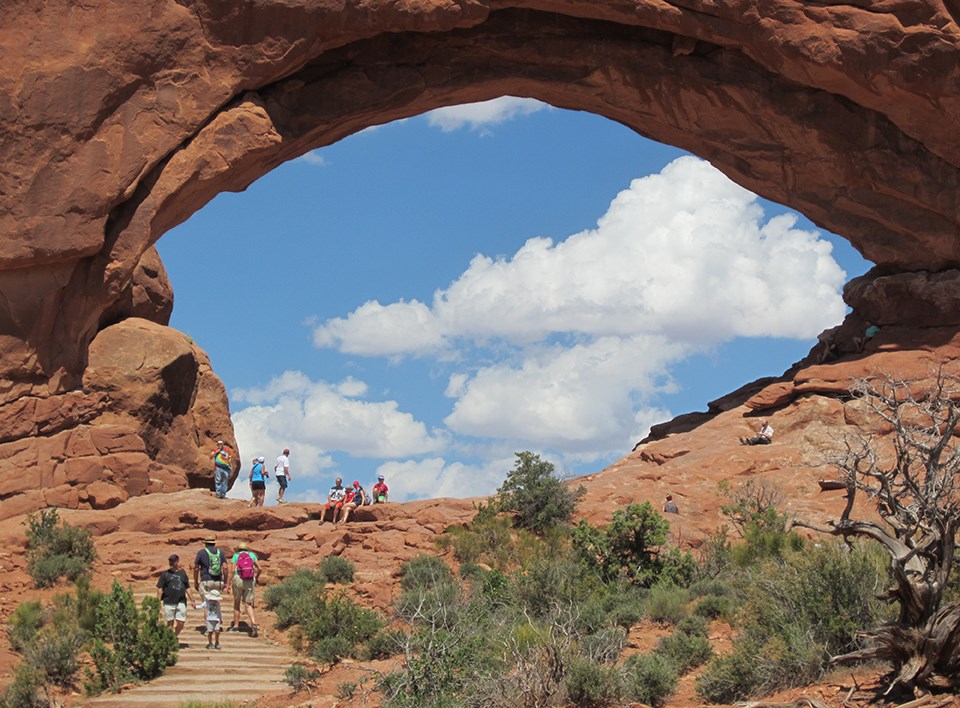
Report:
0,0,960,508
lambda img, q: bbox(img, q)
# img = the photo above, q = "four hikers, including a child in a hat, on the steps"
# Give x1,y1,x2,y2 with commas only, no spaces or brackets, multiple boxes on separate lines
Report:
157,536,261,650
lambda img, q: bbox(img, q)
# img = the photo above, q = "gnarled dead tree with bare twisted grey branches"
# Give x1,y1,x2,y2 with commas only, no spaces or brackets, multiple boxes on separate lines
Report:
797,371,960,693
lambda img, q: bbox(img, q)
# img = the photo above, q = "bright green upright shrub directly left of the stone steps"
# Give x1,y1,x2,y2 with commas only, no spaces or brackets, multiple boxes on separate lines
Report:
86,581,177,693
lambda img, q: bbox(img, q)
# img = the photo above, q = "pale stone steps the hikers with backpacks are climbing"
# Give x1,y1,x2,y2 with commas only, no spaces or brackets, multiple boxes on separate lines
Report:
85,592,297,708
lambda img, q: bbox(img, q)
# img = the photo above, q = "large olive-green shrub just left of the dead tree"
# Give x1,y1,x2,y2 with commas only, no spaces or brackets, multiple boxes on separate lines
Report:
698,545,886,703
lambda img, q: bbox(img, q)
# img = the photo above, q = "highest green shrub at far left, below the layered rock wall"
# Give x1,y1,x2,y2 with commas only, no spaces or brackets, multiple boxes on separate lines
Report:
26,509,97,588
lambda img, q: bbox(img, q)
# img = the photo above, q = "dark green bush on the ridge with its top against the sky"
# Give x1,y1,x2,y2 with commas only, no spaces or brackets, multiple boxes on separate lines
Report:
497,452,586,534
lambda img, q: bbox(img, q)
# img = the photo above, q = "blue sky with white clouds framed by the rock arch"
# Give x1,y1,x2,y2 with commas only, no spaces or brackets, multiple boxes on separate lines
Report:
158,98,869,500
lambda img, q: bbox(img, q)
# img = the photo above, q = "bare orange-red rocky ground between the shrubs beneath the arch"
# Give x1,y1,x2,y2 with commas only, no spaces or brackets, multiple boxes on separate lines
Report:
0,329,960,706
